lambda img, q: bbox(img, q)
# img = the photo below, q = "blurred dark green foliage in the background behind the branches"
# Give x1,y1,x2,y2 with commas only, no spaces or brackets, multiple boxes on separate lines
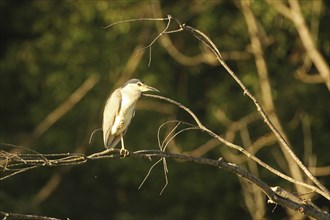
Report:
0,0,330,220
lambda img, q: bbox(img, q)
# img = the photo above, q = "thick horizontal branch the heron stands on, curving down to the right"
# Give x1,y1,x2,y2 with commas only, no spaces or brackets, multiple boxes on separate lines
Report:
0,149,330,220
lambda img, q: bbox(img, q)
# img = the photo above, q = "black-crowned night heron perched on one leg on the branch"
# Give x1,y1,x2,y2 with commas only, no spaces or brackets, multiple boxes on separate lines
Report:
102,79,159,156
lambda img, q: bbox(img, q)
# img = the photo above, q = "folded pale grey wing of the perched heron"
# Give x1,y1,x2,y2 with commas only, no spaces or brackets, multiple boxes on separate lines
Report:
102,89,121,148
